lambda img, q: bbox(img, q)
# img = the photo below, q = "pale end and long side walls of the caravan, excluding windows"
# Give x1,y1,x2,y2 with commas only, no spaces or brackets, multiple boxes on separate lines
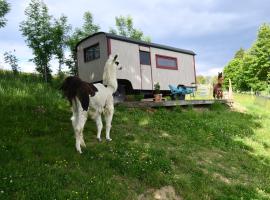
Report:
77,34,195,90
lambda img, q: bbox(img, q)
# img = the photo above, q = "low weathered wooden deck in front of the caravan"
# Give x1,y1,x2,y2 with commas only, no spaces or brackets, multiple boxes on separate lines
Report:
119,99,233,108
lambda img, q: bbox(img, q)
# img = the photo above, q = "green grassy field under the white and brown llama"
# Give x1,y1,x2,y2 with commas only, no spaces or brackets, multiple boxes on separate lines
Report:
0,72,270,200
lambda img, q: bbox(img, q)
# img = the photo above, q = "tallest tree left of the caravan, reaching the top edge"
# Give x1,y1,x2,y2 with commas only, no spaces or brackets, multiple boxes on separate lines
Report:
20,0,54,82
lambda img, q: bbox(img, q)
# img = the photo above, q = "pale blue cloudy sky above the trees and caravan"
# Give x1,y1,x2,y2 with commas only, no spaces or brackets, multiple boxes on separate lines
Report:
0,0,270,76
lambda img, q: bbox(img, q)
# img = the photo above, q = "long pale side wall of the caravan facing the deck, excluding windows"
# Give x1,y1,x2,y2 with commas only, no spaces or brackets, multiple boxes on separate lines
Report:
110,39,195,90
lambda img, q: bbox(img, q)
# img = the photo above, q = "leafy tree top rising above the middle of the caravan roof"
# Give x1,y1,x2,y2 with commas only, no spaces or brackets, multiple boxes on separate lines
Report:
109,15,151,42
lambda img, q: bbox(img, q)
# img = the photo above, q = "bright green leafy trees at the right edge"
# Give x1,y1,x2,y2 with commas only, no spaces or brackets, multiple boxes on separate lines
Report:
224,24,270,91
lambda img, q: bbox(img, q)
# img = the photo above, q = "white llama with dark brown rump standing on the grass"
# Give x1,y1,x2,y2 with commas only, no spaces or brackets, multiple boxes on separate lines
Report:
61,55,121,153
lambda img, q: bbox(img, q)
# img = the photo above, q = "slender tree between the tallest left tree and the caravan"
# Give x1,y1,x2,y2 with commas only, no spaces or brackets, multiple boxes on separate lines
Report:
52,16,71,73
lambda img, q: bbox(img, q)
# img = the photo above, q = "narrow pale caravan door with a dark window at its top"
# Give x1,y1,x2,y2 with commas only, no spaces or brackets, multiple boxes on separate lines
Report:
139,46,153,90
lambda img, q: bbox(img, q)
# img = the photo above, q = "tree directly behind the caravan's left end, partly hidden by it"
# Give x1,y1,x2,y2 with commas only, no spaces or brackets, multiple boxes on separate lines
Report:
65,12,100,75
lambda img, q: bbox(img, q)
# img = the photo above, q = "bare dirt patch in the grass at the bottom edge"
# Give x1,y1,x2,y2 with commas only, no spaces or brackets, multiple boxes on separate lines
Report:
138,186,182,200
